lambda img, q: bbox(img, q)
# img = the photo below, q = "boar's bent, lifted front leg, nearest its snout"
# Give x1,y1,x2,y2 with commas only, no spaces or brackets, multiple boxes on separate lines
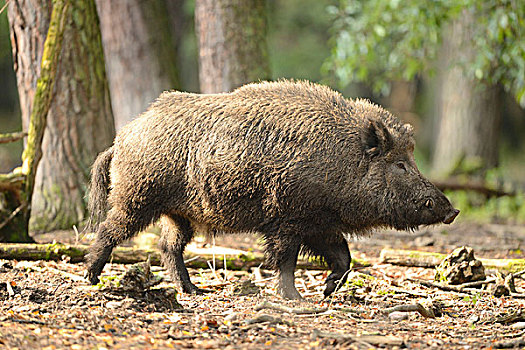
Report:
303,235,351,297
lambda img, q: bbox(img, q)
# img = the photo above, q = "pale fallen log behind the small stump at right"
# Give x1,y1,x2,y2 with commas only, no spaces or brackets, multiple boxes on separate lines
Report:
380,248,525,273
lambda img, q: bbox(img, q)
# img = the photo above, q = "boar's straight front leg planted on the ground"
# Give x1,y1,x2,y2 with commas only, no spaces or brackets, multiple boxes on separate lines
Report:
265,233,302,299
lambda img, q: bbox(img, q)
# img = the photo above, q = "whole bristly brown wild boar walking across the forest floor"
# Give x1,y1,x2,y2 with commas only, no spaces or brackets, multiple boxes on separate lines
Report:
87,80,459,299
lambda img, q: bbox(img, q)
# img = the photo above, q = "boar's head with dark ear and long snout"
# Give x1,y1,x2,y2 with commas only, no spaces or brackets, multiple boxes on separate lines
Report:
361,115,459,230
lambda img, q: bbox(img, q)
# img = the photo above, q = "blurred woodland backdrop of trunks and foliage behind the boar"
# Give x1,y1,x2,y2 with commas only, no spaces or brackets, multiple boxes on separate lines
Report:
0,0,525,238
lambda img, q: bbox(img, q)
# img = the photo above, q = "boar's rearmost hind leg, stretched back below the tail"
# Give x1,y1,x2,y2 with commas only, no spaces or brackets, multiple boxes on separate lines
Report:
86,208,156,284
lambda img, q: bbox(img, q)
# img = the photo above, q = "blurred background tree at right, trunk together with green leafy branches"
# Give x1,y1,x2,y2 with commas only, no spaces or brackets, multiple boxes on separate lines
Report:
325,0,525,172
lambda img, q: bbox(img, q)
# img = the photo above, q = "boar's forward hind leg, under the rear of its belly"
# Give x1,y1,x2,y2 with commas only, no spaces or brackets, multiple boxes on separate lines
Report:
160,215,201,294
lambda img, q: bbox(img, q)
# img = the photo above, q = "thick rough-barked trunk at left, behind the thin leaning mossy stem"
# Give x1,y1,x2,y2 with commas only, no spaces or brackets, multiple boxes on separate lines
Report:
8,0,114,231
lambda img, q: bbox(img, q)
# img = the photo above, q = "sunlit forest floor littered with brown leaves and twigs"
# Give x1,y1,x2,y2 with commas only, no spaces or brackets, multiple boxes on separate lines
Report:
0,222,525,349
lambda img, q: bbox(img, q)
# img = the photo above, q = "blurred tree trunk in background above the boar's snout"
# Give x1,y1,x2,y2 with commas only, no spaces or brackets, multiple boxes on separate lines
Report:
433,10,501,176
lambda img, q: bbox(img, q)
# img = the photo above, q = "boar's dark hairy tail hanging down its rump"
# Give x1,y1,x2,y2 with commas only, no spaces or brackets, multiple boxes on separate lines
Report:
87,147,113,231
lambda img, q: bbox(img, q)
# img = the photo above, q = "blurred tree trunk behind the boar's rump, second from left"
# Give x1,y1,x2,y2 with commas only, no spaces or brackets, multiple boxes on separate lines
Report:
96,0,182,130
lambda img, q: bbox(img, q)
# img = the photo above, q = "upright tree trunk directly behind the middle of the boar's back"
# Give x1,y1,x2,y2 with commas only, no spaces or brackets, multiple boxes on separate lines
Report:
195,0,270,93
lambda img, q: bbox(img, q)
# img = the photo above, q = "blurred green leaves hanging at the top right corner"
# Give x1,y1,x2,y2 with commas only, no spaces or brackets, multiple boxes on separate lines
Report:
324,0,525,106
